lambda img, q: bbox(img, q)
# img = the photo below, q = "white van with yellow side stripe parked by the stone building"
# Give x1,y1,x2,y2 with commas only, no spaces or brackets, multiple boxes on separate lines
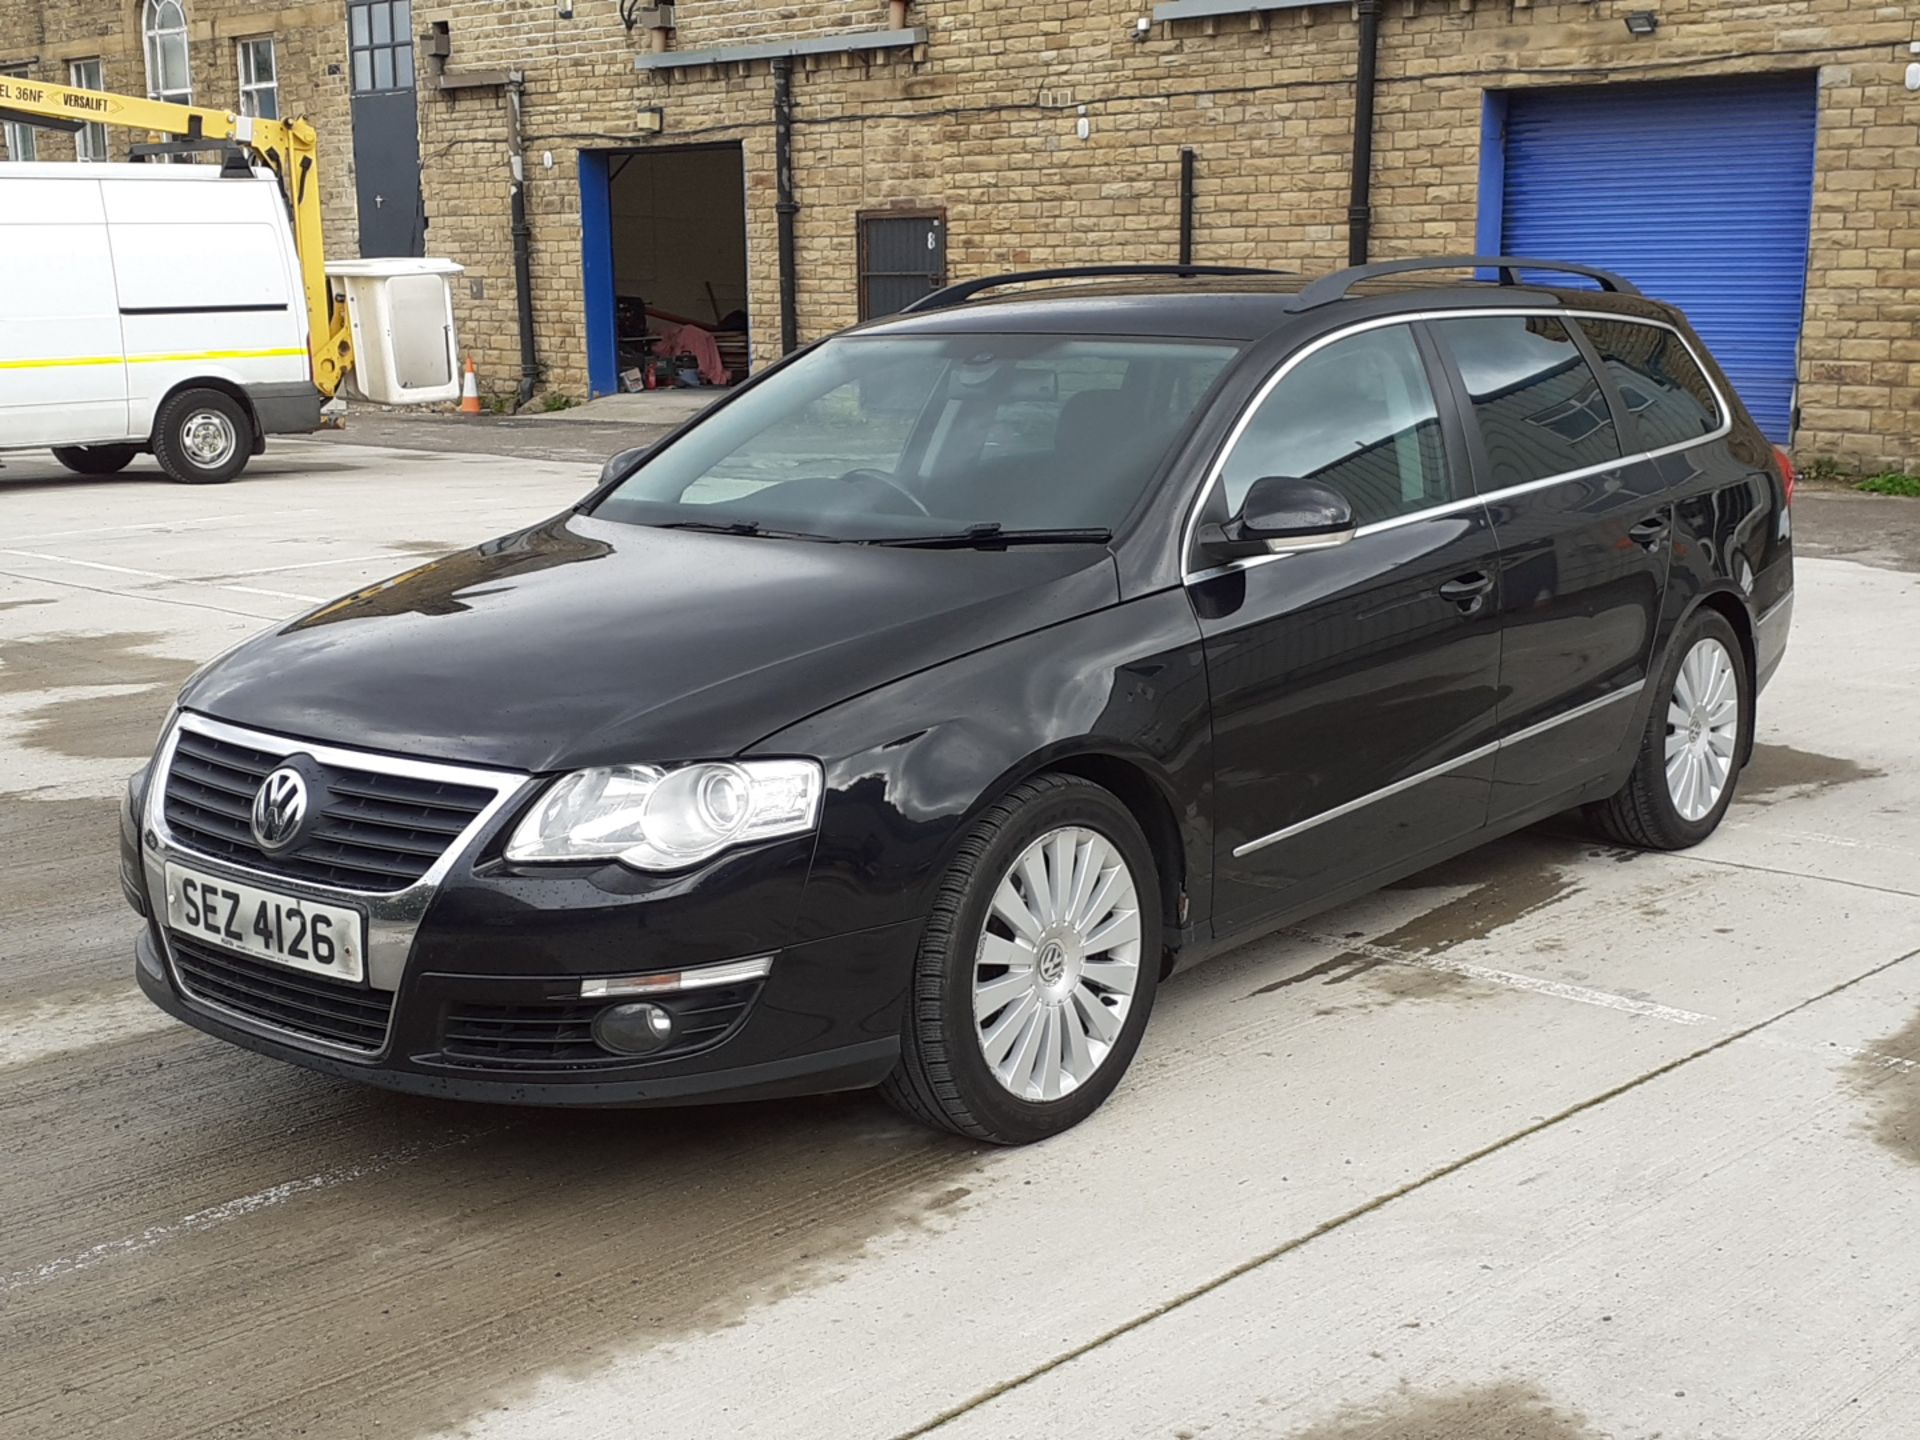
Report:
0,163,323,484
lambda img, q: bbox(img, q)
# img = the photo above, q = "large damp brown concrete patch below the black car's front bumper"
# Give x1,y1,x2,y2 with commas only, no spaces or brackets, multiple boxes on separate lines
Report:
8,1075,985,1436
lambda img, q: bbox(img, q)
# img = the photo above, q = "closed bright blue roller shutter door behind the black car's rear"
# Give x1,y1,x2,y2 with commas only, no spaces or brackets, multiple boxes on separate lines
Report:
1496,73,1816,444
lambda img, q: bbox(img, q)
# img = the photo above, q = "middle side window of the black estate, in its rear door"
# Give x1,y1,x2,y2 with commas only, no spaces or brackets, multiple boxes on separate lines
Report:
1432,315,1622,490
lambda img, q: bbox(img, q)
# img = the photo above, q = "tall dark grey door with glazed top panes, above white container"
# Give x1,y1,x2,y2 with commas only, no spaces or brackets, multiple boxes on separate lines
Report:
348,0,426,255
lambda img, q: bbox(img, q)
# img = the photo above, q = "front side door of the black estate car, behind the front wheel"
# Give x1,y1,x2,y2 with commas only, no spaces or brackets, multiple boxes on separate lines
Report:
1187,323,1500,933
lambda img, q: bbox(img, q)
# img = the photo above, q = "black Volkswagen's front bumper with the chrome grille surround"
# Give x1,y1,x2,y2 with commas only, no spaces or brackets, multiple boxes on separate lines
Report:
121,716,920,1106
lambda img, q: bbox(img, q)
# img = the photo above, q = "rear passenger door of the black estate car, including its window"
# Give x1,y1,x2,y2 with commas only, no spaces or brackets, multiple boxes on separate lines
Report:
1430,313,1672,822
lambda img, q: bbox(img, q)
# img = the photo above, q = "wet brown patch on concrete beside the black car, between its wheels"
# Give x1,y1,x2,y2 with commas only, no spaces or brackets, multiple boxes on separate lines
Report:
1248,845,1578,1004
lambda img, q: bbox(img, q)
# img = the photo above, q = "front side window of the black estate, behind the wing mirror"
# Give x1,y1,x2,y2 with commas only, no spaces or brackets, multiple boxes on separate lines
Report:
1221,324,1453,524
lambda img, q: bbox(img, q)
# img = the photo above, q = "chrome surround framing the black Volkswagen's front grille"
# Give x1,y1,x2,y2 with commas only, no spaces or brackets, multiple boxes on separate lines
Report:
140,710,534,1062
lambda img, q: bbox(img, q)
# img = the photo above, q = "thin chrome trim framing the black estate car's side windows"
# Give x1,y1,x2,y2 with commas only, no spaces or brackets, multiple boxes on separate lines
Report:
1181,305,1734,586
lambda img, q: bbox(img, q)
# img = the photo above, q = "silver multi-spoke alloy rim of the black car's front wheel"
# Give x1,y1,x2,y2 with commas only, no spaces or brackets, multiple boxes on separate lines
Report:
973,826,1140,1100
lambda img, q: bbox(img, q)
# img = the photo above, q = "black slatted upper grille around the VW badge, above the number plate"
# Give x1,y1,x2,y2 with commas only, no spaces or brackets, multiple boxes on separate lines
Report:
165,726,493,895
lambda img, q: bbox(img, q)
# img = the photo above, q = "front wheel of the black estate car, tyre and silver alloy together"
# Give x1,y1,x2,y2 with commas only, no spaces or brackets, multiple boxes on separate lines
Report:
883,774,1162,1144
